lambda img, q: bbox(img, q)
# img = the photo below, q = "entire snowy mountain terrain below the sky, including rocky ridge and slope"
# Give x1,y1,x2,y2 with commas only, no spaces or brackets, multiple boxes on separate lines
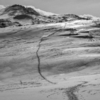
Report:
0,4,100,100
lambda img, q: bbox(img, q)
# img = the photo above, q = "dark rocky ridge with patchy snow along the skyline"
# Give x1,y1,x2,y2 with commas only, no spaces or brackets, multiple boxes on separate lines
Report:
0,4,100,28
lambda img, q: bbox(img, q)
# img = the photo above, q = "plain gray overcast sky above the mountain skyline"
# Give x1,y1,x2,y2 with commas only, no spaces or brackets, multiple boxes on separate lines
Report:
0,0,100,17
